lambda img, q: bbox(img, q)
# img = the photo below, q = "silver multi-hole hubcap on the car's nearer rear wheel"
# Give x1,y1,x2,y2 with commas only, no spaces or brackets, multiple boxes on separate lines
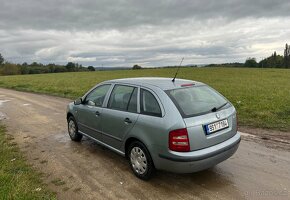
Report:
130,147,147,174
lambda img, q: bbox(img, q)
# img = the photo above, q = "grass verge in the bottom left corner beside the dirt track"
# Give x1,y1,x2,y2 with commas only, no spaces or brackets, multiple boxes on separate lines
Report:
0,125,56,200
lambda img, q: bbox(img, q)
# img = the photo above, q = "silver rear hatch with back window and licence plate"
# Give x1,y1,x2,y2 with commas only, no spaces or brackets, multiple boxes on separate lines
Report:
166,85,237,151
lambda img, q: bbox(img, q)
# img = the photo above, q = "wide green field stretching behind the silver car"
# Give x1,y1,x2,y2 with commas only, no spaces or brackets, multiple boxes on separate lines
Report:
0,68,290,131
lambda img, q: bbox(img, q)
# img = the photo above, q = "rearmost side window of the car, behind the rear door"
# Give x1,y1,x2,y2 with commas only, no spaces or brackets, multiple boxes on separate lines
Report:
140,89,162,117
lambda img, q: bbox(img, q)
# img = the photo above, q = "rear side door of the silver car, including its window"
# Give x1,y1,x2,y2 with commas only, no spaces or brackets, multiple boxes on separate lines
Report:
102,85,139,149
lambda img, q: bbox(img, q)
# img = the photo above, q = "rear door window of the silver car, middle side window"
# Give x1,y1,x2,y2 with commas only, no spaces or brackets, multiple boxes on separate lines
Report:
108,85,138,112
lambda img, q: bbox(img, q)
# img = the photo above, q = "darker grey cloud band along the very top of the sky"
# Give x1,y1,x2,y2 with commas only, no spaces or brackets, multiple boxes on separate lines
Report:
0,0,290,31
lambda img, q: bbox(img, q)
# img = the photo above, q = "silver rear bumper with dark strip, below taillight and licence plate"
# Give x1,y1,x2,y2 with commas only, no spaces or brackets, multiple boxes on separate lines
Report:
154,132,241,173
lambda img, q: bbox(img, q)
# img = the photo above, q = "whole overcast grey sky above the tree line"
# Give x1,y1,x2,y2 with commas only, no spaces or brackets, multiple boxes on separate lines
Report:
0,0,290,67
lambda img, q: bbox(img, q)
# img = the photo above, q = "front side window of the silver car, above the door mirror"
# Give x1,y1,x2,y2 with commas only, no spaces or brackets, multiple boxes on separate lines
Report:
85,85,111,107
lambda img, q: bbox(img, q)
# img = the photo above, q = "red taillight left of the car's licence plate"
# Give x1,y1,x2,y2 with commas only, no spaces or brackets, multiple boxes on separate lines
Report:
169,128,190,152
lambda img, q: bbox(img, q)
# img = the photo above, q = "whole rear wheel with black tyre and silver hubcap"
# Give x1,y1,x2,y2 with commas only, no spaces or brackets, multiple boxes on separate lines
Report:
128,141,155,180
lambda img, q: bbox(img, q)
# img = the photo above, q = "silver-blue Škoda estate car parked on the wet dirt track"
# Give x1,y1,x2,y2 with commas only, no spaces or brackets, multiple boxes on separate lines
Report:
67,78,241,180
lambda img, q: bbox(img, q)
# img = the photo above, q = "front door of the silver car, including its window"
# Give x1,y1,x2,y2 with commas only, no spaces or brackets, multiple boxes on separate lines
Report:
77,84,111,141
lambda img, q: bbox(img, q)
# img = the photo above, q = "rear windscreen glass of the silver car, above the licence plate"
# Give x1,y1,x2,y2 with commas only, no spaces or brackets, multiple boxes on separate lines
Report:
166,85,229,117
